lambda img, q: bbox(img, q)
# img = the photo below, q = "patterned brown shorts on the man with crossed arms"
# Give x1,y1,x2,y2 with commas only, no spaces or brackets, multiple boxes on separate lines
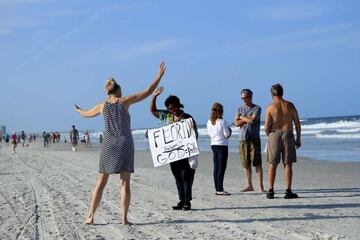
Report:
239,138,261,168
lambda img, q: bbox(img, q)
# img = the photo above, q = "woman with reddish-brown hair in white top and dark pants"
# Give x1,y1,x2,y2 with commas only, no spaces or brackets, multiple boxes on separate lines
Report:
206,103,231,196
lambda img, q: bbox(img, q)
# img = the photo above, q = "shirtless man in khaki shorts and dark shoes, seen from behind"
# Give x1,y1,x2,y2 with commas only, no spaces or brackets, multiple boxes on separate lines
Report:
265,84,301,199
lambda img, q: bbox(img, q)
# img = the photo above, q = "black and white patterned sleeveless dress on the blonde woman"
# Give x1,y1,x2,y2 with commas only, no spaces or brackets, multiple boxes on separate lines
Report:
99,102,134,173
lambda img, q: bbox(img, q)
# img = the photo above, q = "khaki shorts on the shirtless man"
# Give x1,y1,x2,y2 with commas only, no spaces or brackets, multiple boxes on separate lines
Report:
266,131,296,164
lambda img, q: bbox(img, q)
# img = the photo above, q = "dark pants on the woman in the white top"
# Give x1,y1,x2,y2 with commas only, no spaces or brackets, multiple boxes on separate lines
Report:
211,145,228,192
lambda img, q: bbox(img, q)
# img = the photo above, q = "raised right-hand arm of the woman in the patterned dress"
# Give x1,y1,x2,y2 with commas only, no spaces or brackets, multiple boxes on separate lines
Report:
123,62,166,106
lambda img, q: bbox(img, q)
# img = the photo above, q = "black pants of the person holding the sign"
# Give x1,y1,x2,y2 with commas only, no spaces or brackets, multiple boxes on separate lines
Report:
170,158,195,203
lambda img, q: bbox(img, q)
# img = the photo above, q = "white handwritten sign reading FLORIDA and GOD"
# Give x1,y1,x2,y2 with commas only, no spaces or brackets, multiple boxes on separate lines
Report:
148,119,199,167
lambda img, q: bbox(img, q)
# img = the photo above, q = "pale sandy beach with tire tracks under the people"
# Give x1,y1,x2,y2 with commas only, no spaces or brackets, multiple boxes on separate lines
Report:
0,142,360,239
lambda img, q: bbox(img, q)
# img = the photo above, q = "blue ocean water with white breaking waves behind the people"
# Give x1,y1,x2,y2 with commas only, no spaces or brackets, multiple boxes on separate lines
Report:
65,116,360,162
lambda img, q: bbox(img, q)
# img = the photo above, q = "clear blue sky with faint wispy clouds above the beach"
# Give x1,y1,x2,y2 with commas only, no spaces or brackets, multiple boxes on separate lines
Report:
0,0,360,132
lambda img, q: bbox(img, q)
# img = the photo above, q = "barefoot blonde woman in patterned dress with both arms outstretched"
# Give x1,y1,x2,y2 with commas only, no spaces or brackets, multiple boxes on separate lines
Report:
75,62,165,224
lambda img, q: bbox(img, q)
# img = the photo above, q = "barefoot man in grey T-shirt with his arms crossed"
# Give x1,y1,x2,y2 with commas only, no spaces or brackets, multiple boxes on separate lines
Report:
234,89,264,192
